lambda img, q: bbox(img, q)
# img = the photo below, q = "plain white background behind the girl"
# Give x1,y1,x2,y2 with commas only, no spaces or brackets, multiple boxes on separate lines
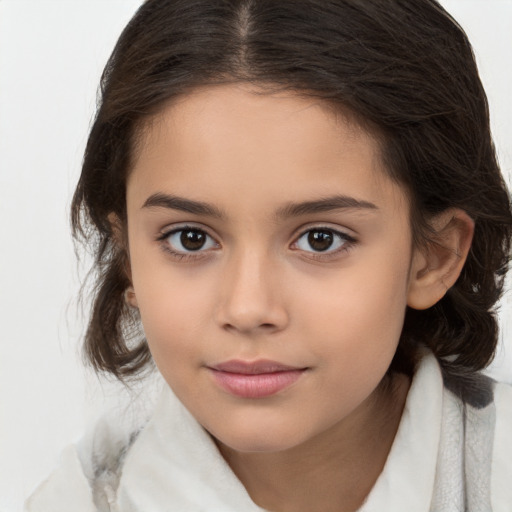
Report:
0,0,512,512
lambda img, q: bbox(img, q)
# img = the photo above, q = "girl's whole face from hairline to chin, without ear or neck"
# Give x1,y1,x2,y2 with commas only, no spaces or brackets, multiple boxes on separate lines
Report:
127,84,413,451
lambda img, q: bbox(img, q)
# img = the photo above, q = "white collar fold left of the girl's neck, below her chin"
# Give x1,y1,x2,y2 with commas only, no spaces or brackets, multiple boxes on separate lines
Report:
117,386,262,512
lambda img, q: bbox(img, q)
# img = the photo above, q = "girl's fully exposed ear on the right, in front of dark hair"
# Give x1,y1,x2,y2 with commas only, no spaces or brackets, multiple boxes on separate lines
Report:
407,208,475,309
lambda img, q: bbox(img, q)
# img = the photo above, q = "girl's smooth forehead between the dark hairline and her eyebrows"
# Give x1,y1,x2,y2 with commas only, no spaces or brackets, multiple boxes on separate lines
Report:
128,84,408,218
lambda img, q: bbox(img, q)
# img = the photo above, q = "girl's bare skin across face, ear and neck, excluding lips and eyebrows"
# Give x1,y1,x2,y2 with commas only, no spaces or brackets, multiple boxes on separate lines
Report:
122,84,472,512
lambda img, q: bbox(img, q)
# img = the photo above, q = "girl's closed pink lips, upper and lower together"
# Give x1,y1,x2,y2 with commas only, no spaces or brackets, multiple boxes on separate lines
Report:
209,360,306,398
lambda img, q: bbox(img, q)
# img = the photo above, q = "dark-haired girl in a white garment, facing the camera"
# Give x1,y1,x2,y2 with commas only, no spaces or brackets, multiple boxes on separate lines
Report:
26,0,512,512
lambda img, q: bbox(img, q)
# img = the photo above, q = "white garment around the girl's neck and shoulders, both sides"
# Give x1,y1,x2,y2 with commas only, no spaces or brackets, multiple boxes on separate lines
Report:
25,354,512,512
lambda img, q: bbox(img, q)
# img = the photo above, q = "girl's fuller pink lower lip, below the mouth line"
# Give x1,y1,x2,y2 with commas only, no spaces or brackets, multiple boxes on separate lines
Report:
207,370,306,398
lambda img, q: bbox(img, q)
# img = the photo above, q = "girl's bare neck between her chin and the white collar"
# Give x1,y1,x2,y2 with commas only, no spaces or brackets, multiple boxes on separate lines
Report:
217,375,409,512
